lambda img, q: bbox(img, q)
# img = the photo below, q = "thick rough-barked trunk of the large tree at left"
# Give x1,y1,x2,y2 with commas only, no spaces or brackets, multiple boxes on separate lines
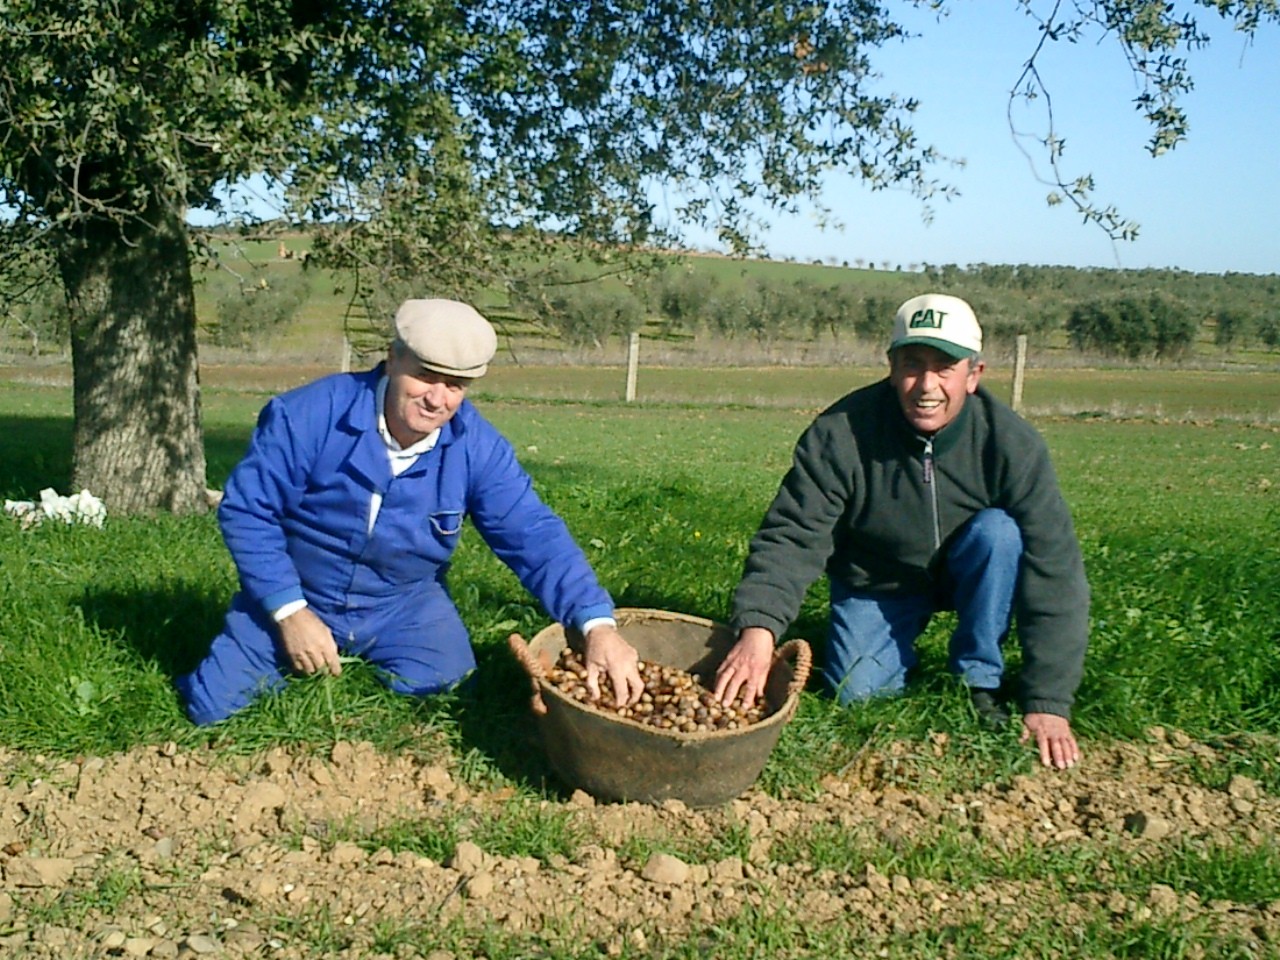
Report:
59,209,207,515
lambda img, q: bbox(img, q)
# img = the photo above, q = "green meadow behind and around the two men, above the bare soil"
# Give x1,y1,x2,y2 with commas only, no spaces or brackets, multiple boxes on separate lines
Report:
0,367,1280,790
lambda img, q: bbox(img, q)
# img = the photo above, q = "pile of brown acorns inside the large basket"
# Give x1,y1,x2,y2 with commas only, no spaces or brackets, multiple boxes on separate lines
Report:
547,646,767,733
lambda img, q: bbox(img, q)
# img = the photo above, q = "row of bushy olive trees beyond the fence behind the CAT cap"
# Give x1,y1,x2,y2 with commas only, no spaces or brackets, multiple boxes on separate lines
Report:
520,268,1280,360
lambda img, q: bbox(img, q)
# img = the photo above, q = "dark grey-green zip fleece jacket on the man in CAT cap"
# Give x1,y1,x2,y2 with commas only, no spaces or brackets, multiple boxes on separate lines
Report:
732,379,1089,717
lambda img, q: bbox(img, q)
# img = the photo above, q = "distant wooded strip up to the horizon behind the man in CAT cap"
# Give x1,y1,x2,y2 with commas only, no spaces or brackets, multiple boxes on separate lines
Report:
516,259,1280,361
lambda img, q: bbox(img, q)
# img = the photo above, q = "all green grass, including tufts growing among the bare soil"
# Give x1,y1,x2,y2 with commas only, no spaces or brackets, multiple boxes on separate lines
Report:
0,367,1280,960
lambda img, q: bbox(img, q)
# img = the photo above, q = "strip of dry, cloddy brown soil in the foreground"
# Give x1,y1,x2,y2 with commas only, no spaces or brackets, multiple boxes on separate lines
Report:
0,735,1280,960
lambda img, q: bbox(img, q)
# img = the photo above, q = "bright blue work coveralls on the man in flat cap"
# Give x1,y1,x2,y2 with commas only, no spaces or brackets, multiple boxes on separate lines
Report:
175,365,613,723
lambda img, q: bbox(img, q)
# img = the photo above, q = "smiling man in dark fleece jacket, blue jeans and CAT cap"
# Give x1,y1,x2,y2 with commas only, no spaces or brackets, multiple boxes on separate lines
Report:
716,293,1089,769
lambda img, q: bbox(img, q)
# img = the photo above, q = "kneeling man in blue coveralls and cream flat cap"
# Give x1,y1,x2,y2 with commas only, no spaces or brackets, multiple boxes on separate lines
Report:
177,300,644,724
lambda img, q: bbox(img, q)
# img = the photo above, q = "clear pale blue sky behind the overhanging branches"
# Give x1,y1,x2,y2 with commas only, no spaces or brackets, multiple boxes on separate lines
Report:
687,6,1280,274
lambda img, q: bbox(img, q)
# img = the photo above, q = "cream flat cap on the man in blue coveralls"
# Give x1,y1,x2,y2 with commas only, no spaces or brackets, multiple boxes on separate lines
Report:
396,300,498,379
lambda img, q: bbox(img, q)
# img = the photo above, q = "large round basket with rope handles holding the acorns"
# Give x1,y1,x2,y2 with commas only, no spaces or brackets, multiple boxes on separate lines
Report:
508,608,812,806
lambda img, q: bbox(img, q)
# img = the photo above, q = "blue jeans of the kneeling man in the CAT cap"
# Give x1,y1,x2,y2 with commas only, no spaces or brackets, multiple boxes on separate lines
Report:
822,508,1023,704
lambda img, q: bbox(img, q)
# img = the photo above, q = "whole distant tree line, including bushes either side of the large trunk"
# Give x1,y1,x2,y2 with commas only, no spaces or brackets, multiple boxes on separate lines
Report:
8,249,1280,361
